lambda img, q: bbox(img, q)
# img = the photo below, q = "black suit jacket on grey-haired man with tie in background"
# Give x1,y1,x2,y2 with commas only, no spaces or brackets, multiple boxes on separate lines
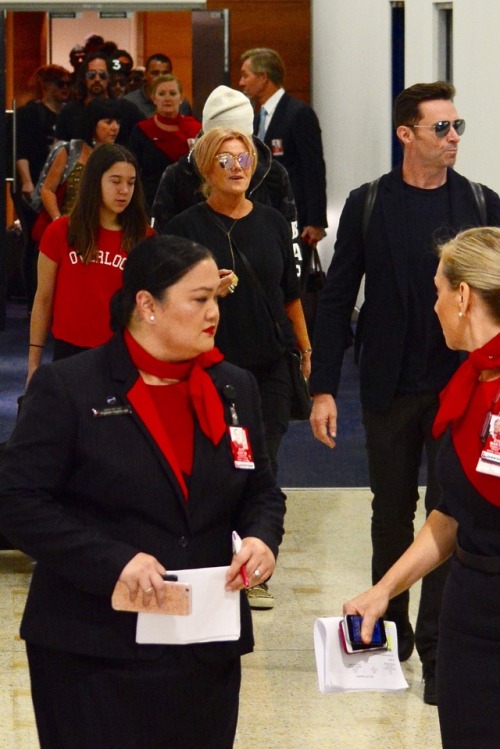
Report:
254,93,328,229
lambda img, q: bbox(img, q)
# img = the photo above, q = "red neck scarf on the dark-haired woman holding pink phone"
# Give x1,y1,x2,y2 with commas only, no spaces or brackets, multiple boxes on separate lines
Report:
124,330,226,445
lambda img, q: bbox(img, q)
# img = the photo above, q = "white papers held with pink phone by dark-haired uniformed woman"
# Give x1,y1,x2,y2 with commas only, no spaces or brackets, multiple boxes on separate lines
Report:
136,567,240,645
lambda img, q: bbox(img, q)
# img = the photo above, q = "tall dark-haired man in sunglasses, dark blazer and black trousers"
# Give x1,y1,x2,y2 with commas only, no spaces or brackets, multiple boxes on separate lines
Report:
310,81,500,704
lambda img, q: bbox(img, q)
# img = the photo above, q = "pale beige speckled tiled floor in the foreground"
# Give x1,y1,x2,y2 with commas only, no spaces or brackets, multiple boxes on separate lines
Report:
0,489,440,749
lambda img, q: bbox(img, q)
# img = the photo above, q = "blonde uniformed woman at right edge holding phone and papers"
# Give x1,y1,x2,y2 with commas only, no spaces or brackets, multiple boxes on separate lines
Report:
344,227,500,749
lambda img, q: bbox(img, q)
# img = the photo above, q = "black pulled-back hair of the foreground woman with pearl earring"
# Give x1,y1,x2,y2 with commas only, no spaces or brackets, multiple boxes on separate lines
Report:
111,234,213,330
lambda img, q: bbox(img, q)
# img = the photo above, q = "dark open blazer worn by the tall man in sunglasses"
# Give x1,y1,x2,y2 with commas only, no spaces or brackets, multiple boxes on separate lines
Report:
310,167,500,411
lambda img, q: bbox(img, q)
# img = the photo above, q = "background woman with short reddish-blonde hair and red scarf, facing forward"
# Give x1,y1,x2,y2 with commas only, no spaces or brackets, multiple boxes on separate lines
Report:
128,75,201,210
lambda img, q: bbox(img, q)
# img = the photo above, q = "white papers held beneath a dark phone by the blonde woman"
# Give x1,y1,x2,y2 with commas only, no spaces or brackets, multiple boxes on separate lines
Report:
314,616,408,694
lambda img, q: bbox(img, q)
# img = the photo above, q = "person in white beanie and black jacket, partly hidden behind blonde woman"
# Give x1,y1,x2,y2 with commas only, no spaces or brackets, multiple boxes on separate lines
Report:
153,86,302,276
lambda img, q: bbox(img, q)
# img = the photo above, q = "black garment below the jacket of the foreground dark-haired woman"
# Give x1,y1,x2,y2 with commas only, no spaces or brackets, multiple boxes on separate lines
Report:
26,643,241,749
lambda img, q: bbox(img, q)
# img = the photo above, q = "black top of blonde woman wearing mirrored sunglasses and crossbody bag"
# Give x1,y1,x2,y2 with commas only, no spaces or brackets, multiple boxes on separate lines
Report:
165,203,300,369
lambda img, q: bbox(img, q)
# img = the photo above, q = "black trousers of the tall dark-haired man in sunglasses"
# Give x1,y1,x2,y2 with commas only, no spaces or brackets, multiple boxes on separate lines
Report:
363,393,448,666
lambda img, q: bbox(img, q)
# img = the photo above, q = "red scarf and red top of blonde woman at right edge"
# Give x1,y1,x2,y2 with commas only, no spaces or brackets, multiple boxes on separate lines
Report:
432,333,500,507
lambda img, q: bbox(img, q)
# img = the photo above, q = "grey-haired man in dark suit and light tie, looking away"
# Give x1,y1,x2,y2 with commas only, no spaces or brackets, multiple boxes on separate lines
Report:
239,48,328,267
